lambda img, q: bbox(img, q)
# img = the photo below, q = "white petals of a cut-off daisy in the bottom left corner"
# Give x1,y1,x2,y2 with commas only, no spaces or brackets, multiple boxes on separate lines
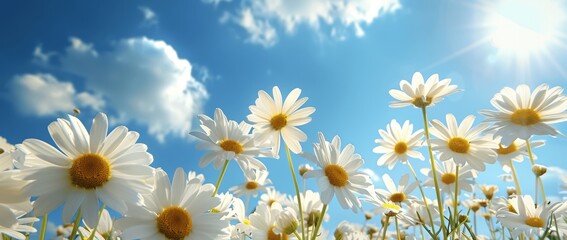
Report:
0,204,39,240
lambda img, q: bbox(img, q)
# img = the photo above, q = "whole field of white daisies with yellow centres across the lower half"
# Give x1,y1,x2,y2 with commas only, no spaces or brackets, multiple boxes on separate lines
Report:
0,73,567,240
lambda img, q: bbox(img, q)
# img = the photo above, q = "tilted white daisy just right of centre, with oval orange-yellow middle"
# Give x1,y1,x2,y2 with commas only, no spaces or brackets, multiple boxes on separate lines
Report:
303,132,373,213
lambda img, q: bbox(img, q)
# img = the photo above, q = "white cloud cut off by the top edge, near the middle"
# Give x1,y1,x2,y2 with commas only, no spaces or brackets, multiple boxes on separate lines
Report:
215,0,401,47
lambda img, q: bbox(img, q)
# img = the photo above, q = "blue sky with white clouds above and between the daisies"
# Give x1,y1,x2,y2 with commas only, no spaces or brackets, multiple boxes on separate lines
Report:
0,0,567,238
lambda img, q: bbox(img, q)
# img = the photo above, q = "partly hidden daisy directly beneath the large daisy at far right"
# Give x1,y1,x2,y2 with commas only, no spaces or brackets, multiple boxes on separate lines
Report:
495,137,545,173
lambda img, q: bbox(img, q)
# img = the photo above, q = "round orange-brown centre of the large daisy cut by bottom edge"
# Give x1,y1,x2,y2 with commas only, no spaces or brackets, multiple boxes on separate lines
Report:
156,206,193,239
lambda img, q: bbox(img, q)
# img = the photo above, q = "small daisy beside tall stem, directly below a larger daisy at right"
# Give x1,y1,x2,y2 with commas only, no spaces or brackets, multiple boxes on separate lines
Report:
421,161,477,193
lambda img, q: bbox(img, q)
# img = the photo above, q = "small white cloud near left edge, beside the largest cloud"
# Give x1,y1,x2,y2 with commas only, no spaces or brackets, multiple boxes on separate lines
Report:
10,74,105,116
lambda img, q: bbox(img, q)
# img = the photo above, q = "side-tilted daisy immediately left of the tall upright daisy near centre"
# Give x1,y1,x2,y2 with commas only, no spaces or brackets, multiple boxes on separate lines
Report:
190,108,268,170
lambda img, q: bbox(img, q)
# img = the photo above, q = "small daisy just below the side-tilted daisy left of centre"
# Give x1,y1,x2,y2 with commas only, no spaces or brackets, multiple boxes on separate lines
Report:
229,168,272,197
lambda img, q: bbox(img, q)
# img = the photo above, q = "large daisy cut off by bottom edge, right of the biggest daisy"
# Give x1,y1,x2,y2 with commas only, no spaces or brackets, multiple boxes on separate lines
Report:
116,168,230,240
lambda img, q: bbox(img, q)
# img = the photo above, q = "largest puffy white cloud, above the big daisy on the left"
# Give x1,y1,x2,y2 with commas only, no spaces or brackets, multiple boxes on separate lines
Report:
51,37,208,141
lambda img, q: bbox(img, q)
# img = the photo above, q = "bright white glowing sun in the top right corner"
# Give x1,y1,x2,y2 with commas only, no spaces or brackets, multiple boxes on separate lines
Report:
486,0,565,56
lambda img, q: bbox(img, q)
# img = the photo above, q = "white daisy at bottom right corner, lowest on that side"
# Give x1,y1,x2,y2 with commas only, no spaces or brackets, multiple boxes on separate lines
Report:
496,195,566,238
